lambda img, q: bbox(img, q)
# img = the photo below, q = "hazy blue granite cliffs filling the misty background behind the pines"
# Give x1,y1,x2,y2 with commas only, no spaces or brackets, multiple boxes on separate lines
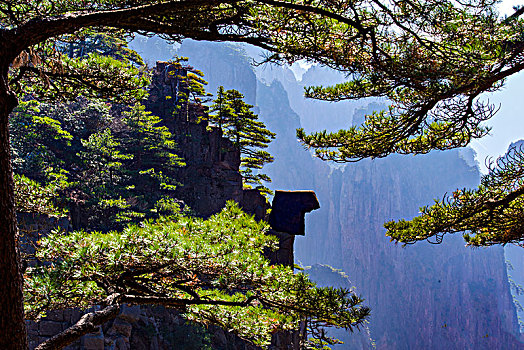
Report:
174,40,524,349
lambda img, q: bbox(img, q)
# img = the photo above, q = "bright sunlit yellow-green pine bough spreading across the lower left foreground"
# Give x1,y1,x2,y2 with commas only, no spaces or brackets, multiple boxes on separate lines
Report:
25,202,369,345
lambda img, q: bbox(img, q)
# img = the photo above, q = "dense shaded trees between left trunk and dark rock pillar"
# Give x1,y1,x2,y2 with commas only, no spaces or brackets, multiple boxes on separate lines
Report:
11,99,184,230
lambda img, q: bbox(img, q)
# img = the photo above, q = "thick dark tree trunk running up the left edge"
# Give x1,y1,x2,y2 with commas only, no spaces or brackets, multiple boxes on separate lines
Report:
0,73,27,350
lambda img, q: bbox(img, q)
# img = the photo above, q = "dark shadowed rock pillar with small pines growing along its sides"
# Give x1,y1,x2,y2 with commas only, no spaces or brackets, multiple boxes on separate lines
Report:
146,62,262,219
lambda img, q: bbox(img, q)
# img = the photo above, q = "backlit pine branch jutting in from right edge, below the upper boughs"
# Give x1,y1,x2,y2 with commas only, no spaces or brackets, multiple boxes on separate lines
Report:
385,148,524,246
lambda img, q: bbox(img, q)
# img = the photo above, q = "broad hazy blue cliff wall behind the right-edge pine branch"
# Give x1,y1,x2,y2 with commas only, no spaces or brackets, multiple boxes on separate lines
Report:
297,154,523,349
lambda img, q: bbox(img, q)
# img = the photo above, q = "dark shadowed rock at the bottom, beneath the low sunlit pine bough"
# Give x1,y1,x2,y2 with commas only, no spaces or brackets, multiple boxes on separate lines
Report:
27,305,260,350
